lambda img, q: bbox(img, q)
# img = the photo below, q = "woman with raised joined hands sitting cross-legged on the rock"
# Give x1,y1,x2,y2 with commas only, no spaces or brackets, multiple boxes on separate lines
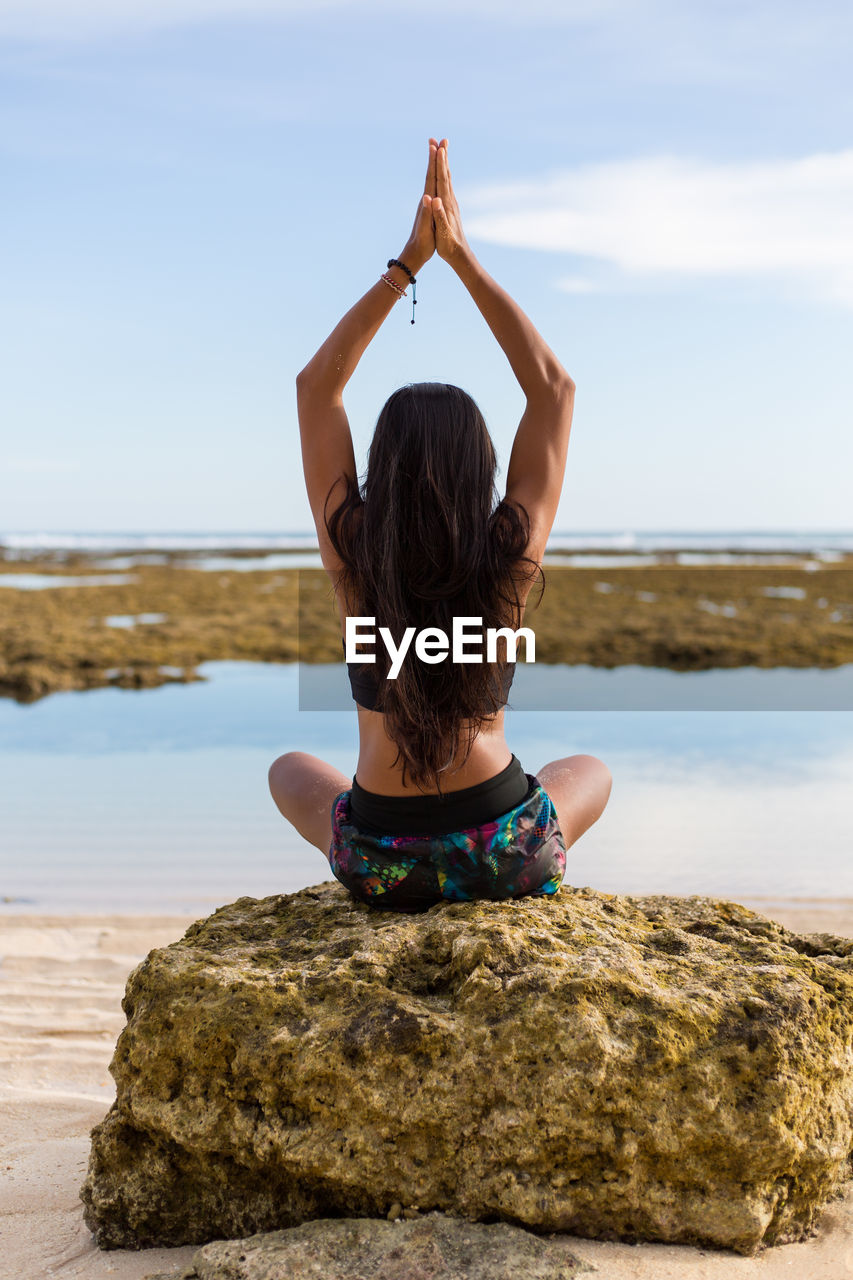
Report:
269,138,611,911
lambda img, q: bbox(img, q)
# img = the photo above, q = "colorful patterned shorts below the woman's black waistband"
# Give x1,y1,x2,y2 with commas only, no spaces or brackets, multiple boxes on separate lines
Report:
329,774,566,911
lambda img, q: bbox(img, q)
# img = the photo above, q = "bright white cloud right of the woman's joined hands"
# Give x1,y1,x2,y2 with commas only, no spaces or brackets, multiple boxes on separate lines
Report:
460,150,853,306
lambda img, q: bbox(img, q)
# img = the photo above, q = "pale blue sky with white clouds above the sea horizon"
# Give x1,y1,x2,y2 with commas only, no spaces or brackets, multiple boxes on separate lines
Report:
0,0,853,531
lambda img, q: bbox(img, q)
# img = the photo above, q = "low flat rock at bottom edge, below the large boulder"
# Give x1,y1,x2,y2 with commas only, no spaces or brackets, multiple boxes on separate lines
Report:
140,1213,594,1280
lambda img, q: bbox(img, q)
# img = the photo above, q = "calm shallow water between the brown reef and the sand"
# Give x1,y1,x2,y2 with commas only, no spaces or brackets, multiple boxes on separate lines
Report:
0,662,853,914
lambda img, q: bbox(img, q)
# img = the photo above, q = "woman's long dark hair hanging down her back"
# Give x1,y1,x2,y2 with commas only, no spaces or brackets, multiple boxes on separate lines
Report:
324,383,544,791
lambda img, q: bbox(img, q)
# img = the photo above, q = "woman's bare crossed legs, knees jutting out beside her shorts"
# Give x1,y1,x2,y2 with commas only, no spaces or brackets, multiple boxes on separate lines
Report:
269,751,613,855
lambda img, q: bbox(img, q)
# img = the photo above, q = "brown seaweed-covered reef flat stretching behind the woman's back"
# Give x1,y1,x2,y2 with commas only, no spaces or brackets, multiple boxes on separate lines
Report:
0,553,853,701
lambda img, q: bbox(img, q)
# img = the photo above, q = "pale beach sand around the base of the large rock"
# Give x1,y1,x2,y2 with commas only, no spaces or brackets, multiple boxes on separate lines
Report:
0,899,853,1280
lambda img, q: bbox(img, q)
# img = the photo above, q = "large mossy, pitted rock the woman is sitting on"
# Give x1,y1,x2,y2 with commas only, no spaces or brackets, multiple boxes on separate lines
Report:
81,883,853,1253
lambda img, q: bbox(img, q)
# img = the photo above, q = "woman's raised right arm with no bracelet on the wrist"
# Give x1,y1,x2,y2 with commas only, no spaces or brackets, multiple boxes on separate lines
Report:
430,138,575,561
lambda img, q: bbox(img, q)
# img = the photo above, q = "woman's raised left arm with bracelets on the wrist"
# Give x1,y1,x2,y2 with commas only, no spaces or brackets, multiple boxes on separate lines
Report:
296,138,437,572
